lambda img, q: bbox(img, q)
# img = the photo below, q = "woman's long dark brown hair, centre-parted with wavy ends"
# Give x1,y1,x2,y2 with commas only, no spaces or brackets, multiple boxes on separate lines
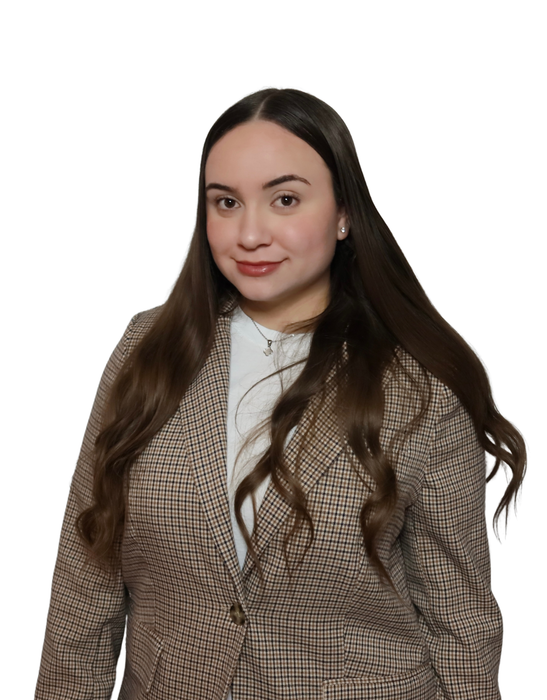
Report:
78,88,526,579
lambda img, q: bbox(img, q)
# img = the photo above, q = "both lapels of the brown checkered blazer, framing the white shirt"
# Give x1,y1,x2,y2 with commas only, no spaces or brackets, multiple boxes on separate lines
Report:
179,315,343,600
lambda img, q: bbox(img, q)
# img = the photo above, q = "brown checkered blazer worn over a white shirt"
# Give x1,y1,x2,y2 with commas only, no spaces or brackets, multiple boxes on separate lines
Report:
36,308,502,700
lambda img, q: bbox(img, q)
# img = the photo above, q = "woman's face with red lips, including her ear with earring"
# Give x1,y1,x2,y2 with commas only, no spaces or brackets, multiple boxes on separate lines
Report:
205,120,348,330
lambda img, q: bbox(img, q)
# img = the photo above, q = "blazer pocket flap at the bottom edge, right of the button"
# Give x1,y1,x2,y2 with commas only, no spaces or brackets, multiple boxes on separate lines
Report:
321,663,437,700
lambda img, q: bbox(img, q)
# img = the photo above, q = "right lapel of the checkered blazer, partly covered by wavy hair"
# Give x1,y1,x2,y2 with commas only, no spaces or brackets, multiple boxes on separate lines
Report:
242,371,344,579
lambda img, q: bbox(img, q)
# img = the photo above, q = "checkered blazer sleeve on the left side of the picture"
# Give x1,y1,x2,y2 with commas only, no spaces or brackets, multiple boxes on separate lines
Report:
35,314,138,700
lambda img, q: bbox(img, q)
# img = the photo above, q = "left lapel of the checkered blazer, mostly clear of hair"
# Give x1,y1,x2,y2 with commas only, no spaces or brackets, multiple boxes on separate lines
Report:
179,316,243,600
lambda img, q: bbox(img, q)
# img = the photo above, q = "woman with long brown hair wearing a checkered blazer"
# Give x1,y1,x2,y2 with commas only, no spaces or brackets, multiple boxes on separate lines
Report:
36,89,525,700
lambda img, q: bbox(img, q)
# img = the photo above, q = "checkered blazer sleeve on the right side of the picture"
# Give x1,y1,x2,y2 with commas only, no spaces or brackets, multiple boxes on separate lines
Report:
402,386,502,700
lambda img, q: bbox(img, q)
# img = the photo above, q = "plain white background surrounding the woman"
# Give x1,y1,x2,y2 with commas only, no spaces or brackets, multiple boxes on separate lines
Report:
0,0,547,700
